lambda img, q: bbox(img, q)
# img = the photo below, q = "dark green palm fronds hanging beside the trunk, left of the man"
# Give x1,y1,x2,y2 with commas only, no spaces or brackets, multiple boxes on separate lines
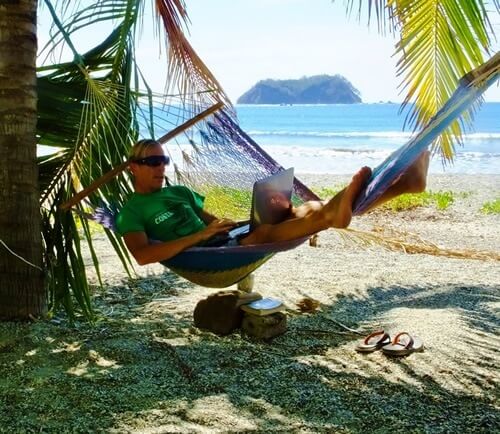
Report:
37,10,144,318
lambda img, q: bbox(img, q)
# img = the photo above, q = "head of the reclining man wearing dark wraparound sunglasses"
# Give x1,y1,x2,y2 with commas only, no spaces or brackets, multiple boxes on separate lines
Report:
129,139,170,193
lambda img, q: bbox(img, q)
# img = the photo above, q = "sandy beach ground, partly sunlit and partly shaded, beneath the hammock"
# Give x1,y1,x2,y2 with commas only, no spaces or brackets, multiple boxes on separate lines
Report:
0,174,500,433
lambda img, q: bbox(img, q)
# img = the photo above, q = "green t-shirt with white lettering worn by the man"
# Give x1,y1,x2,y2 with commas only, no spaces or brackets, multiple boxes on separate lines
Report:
116,185,206,241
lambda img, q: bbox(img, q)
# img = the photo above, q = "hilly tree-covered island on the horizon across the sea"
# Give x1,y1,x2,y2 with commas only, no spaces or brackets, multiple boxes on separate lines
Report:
236,74,362,104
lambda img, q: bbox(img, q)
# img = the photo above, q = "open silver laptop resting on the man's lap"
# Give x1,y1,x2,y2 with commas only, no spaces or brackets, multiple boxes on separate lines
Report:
204,167,294,246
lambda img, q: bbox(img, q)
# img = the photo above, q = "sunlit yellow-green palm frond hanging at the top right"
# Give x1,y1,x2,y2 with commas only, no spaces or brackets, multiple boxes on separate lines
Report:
340,0,500,161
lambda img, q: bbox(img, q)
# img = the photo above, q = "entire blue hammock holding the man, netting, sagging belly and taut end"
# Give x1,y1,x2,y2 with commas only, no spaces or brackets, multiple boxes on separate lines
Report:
72,52,500,288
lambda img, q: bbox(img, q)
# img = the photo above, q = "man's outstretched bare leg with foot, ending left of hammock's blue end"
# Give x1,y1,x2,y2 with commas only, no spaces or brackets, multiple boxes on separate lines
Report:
240,167,371,245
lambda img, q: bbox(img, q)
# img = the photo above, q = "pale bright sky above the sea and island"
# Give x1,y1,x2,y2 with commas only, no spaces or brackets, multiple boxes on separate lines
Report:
39,0,500,102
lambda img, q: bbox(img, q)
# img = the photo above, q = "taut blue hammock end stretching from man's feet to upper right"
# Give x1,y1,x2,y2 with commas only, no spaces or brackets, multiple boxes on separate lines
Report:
353,52,500,215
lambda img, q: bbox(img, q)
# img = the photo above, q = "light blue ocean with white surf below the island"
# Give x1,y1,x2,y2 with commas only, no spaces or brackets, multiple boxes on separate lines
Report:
236,103,500,174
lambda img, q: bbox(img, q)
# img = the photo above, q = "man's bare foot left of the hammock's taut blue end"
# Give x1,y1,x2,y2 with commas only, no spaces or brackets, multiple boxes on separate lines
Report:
322,166,372,228
